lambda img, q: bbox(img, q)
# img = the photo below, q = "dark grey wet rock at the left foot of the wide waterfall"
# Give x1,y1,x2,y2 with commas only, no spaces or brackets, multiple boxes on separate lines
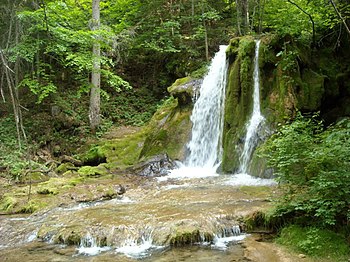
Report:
128,154,175,177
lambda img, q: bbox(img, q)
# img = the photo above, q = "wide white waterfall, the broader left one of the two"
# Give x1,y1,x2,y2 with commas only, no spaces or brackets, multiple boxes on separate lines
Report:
185,45,228,171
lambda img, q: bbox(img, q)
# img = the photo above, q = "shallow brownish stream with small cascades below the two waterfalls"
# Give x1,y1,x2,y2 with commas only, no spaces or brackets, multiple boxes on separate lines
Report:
0,175,274,261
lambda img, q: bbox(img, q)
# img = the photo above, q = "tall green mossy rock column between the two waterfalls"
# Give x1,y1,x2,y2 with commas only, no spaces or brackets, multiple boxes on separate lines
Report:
222,37,255,172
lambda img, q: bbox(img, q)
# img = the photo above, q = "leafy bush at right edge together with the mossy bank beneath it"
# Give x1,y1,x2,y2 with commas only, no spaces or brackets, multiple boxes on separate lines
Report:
254,114,350,261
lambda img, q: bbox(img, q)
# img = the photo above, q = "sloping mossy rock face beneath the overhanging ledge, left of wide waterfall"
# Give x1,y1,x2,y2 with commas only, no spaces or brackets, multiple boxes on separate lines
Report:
140,98,192,160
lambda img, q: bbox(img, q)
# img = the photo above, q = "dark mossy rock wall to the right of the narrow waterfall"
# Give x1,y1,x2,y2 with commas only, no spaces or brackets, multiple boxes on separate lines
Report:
259,35,325,124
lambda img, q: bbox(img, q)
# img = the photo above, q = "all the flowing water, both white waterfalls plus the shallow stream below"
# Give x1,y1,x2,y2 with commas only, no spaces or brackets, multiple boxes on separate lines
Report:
0,42,273,261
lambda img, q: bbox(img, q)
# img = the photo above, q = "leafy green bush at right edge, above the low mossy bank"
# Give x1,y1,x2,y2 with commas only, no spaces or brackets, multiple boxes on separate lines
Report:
265,115,350,228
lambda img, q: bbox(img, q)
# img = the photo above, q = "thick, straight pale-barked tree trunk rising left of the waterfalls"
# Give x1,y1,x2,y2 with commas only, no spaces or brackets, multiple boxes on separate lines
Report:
89,0,101,132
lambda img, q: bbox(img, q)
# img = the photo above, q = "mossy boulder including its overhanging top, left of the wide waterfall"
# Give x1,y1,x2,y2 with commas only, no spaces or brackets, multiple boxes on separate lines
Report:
140,78,196,160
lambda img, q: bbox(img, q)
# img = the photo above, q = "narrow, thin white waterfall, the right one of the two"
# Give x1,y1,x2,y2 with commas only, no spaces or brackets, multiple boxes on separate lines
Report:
239,40,264,173
